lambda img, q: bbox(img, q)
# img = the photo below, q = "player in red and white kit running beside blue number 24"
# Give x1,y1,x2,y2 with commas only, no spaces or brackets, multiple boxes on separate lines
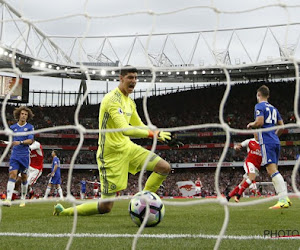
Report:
226,133,262,202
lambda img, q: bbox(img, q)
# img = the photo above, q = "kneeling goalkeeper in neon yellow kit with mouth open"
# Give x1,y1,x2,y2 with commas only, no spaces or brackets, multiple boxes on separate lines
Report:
53,67,171,215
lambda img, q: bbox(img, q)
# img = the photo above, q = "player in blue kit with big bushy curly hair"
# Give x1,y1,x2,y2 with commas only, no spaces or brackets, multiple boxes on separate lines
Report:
3,106,34,207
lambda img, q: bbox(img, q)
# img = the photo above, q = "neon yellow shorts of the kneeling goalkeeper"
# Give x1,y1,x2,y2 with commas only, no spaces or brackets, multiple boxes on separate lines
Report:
97,142,161,198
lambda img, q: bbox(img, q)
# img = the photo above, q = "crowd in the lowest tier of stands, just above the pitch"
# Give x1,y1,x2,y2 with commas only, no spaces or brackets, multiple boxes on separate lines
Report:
0,166,300,198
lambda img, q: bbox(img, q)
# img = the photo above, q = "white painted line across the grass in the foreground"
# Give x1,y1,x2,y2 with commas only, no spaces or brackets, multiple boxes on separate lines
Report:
0,232,300,240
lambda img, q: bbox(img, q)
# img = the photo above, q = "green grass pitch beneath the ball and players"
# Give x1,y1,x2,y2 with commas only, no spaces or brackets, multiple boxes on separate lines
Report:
0,198,300,250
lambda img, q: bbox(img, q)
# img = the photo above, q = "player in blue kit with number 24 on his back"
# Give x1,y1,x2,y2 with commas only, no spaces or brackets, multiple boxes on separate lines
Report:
247,85,291,209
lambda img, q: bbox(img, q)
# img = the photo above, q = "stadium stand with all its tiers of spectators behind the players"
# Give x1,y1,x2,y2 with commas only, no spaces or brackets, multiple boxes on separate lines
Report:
0,81,300,197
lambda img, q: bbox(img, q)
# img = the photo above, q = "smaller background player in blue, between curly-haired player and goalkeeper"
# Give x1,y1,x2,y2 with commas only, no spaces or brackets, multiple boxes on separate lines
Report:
44,150,64,199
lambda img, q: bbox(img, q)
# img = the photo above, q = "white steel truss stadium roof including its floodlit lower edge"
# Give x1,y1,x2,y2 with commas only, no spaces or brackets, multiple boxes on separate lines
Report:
0,0,300,83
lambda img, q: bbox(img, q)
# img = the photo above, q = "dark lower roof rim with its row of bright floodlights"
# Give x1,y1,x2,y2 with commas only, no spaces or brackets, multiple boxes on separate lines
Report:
0,47,299,83
